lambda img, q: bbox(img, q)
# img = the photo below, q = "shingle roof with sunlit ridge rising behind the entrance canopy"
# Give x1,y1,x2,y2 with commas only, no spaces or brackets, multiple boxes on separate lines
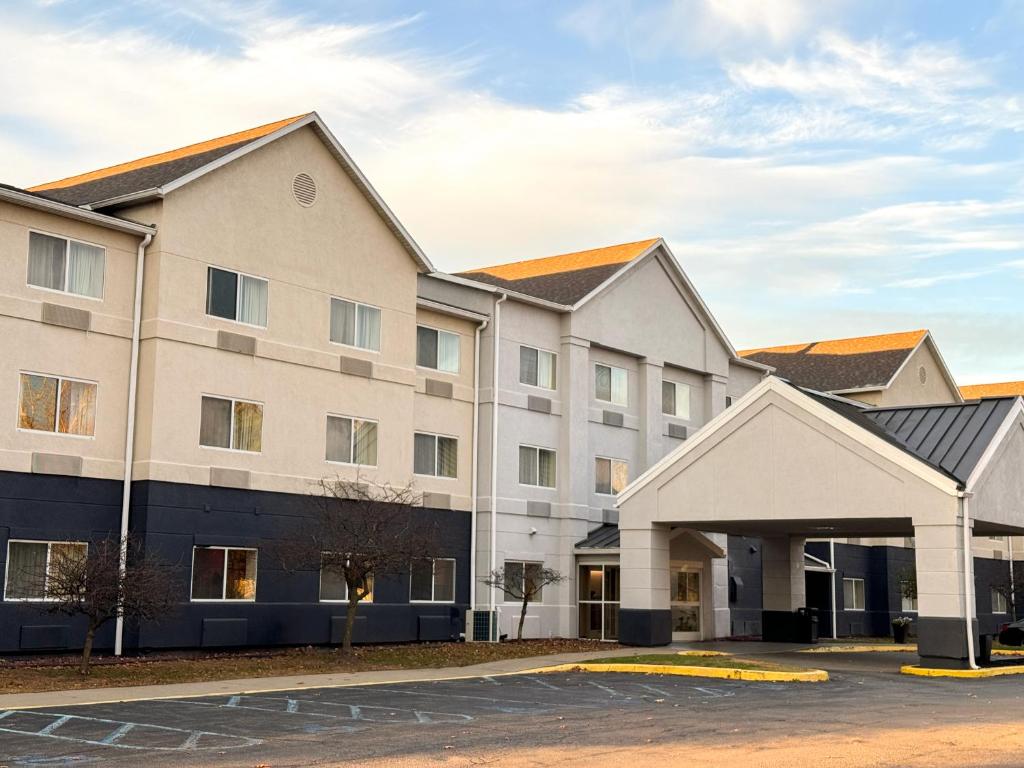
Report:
738,330,928,392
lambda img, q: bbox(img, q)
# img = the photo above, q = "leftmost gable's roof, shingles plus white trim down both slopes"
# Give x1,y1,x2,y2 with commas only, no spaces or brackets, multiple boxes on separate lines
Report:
28,112,434,272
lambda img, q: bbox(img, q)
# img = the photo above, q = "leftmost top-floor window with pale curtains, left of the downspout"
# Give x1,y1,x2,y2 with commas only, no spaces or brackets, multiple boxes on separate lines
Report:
29,232,104,299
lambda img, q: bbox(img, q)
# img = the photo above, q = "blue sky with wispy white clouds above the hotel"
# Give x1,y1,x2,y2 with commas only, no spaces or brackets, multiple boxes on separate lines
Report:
0,0,1024,383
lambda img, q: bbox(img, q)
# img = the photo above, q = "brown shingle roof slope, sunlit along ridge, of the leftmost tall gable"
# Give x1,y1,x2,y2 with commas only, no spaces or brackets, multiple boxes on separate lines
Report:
28,115,305,206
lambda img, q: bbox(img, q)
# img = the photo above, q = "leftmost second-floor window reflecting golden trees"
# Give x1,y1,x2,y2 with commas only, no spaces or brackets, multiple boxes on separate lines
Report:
17,374,96,437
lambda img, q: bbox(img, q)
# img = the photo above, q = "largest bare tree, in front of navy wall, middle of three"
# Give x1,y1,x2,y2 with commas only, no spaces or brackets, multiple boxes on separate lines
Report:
274,478,440,653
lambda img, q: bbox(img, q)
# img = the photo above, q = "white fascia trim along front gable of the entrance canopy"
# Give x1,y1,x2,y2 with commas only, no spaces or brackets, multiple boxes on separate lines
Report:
615,376,959,507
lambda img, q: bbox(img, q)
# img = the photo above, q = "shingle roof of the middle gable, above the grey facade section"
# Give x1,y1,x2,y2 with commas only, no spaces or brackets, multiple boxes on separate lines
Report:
458,238,659,305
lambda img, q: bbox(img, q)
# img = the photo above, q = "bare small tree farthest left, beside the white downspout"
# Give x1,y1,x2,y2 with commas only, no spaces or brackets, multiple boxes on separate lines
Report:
20,537,181,675
